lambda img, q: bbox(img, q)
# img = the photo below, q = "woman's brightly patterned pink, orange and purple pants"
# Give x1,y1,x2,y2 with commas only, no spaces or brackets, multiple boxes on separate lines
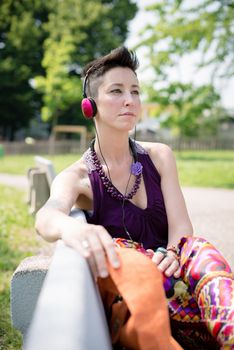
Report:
114,237,234,350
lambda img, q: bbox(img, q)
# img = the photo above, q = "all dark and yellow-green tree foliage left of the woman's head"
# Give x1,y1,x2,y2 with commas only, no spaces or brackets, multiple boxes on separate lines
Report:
0,0,137,138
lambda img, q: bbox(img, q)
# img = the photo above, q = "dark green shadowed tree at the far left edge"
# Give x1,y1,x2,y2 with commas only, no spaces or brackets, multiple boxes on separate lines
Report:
0,0,49,139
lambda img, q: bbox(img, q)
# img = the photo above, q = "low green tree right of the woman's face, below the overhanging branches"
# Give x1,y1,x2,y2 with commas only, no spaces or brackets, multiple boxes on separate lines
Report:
148,82,220,137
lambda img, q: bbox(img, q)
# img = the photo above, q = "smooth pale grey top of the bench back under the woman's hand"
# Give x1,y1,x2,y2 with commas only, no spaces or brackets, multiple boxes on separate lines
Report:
24,242,112,350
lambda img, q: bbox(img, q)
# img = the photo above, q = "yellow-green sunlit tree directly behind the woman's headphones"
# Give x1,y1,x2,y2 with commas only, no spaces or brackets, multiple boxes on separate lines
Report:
35,0,136,124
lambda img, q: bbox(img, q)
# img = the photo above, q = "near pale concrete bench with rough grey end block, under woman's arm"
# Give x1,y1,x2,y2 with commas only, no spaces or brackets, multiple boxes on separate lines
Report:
11,209,112,350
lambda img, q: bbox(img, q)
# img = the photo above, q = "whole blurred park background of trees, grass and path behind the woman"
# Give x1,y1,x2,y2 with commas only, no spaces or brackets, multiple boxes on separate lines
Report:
0,0,234,350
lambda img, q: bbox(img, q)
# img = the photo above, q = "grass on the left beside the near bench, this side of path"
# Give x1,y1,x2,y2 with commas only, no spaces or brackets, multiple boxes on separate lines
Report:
0,185,48,350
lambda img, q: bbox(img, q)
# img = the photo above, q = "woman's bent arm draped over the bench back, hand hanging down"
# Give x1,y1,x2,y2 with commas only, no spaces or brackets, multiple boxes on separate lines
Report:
35,165,119,277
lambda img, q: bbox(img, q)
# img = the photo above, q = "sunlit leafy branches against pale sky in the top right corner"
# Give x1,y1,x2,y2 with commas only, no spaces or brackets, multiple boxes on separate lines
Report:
142,0,234,77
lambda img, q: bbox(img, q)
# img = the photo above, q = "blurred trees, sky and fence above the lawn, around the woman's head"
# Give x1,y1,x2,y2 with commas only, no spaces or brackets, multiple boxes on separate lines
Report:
0,0,234,154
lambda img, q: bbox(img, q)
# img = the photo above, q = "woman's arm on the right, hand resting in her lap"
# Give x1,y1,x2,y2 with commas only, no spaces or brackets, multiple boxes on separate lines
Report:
150,144,193,277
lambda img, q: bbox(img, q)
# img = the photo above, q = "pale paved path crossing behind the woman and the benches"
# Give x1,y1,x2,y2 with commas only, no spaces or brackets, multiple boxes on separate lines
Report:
0,173,234,268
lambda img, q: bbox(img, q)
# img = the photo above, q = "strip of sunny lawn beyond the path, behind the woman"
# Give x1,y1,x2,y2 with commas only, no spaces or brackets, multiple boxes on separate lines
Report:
0,151,234,189
